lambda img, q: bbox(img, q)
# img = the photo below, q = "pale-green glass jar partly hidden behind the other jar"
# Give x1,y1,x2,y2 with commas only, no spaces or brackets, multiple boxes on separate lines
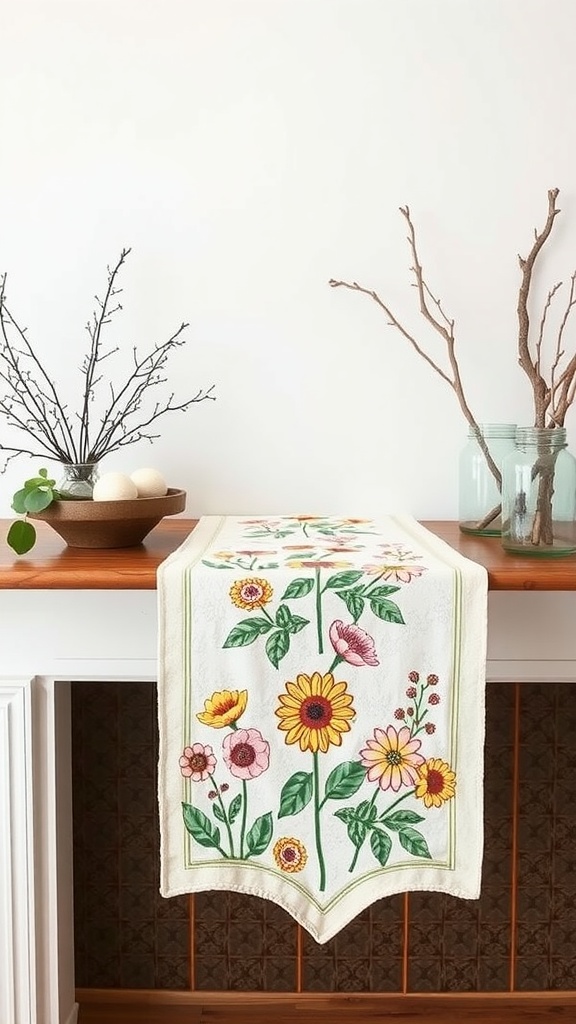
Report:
458,423,516,537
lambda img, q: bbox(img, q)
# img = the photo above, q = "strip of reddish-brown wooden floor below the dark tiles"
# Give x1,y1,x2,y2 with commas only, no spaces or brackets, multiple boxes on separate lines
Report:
78,992,576,1024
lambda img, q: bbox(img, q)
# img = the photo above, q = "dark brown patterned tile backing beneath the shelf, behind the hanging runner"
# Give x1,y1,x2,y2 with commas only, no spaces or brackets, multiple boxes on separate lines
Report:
73,683,576,992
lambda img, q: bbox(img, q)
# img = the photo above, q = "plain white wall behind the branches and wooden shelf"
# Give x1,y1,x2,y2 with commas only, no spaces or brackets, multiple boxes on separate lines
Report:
0,0,576,518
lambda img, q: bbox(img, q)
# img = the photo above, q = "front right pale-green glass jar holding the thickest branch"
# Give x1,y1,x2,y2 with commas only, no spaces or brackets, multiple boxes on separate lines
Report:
502,427,576,558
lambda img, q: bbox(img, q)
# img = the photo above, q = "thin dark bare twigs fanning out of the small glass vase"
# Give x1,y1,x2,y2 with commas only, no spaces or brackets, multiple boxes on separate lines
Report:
0,249,215,471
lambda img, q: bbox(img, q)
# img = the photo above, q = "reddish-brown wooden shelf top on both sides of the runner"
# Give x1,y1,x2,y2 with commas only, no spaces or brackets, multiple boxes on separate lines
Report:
0,518,576,591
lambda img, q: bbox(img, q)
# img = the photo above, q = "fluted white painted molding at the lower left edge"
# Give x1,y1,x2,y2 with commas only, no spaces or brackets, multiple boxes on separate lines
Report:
0,679,37,1024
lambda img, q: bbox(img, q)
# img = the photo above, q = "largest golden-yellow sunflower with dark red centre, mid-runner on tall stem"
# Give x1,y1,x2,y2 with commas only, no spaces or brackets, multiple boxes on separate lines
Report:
275,672,355,754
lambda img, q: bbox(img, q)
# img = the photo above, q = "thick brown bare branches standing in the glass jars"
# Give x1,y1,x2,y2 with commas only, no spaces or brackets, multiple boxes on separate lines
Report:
329,188,576,544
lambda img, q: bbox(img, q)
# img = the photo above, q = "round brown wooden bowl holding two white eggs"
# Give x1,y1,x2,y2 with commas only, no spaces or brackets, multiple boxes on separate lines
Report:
29,487,186,548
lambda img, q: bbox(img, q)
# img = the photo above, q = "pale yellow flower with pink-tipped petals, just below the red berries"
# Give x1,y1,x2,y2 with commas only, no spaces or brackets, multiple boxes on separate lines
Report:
360,725,424,793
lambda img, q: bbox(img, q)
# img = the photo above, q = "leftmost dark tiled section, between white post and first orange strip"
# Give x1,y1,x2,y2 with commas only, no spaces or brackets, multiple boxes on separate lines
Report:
72,683,190,989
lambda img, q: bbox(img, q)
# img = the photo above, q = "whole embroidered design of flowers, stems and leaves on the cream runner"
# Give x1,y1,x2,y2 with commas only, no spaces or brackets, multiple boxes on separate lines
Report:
179,516,456,892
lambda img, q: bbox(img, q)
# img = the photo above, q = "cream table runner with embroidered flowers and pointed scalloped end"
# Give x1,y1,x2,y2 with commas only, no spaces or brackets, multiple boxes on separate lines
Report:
158,516,487,942
